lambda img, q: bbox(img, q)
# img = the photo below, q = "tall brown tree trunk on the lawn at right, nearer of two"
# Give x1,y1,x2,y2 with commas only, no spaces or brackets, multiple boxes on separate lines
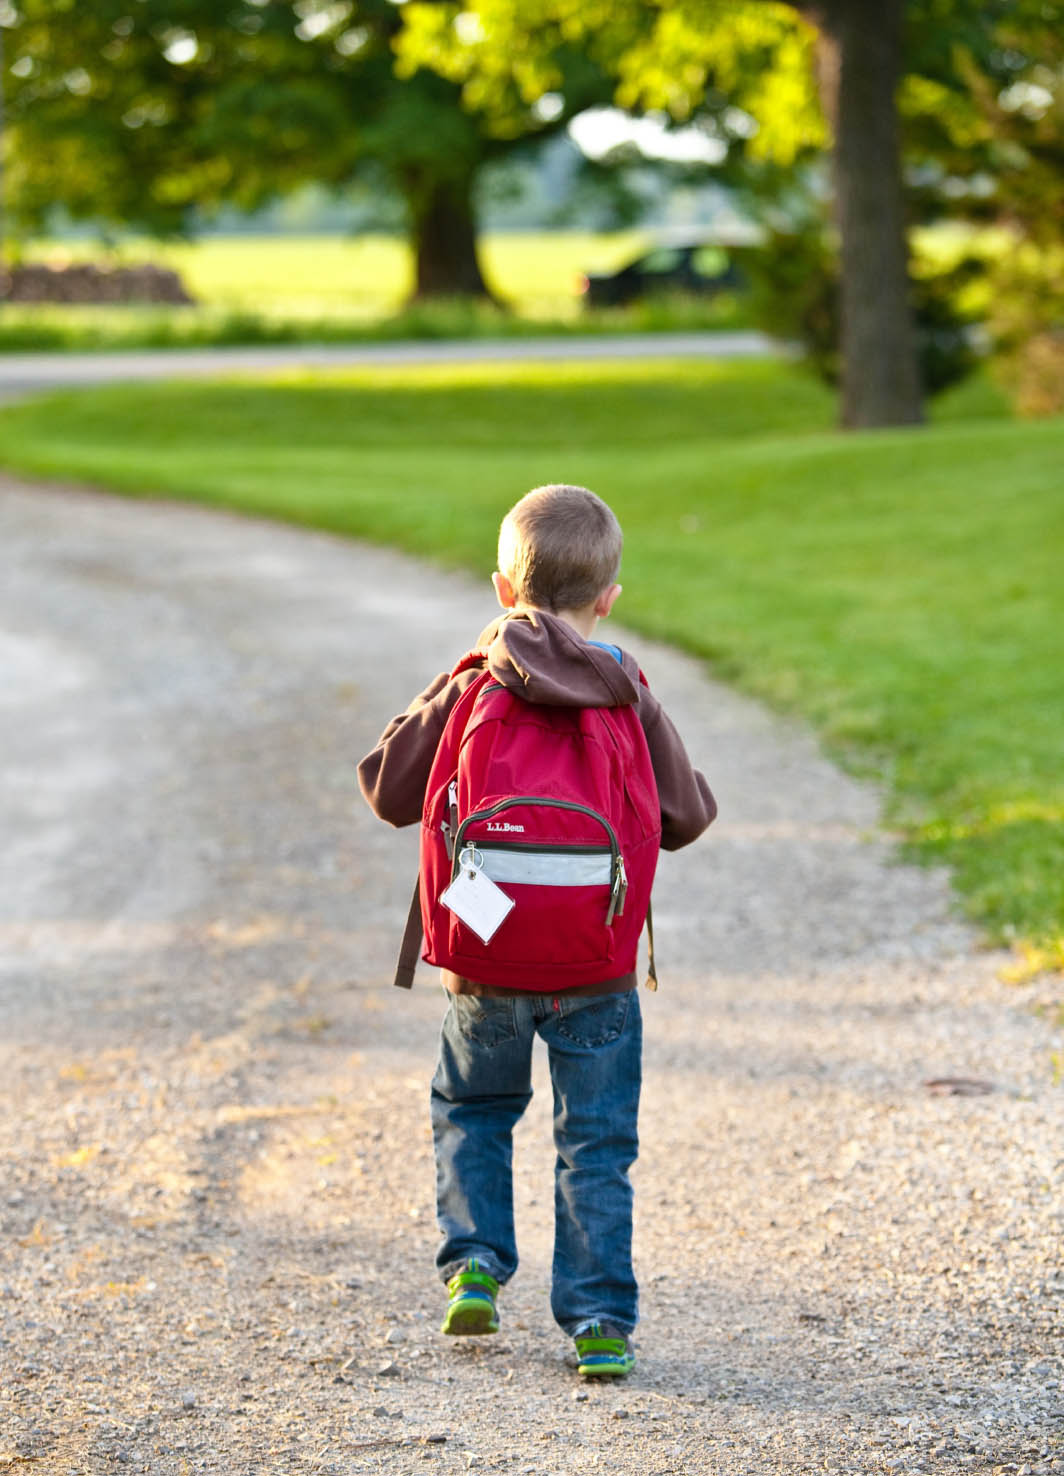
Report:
801,0,922,428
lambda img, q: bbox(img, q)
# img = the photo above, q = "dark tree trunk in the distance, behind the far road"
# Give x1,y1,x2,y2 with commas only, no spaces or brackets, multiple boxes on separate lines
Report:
404,173,491,300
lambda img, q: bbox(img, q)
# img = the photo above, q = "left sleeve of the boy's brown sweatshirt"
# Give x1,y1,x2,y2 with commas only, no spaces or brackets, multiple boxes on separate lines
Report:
359,672,465,825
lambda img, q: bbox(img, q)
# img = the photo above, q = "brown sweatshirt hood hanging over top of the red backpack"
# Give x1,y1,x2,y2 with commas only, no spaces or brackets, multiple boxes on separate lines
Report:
480,610,640,707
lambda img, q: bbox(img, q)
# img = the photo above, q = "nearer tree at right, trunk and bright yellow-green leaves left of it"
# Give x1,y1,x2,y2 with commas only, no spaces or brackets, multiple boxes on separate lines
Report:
401,0,921,427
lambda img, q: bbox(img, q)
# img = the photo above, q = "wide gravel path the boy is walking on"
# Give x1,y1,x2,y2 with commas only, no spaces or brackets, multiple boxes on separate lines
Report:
0,481,1064,1476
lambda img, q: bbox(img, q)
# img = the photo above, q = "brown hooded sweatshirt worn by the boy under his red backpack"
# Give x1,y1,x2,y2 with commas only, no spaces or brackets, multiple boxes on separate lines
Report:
359,610,717,995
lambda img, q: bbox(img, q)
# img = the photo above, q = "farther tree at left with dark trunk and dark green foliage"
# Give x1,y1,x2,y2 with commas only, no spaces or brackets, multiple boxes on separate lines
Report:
0,0,609,295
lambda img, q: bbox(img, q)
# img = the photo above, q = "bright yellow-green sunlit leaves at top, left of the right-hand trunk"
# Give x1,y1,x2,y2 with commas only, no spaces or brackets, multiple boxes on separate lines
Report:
395,0,826,165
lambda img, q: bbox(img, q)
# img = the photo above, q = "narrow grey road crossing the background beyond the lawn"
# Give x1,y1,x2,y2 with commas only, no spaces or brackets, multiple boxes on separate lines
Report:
0,334,781,400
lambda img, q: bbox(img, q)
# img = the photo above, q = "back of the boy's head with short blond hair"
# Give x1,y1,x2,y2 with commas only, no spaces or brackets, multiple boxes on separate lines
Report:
499,483,624,611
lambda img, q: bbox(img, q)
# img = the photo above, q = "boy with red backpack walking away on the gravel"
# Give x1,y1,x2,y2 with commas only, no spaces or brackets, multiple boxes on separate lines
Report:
359,484,716,1377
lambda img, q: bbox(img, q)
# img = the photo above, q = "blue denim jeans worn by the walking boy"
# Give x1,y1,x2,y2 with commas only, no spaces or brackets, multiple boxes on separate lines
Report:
432,990,642,1334
